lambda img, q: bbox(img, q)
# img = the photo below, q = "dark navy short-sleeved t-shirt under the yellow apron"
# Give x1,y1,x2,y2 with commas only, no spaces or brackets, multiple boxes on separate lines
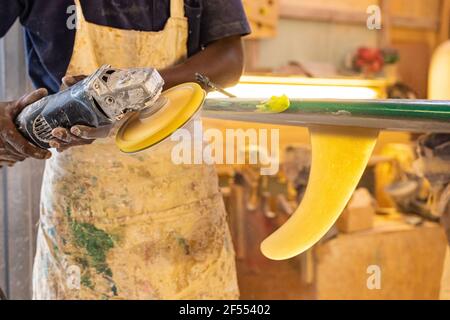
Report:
0,0,250,92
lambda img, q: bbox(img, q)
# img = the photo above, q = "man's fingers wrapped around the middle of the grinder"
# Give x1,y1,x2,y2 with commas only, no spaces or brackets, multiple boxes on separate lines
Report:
49,76,116,152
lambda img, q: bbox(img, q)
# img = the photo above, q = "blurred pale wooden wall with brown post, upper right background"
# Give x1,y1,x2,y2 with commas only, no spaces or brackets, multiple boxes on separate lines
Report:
243,0,448,98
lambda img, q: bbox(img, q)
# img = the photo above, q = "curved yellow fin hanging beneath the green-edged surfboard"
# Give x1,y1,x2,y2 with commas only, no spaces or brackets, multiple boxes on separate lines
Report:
261,126,378,260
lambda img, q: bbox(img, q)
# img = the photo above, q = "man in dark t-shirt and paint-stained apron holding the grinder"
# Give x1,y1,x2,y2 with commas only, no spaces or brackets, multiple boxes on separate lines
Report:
0,0,250,299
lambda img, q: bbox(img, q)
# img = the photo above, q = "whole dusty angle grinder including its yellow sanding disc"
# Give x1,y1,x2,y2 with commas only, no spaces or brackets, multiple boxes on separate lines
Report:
16,65,205,152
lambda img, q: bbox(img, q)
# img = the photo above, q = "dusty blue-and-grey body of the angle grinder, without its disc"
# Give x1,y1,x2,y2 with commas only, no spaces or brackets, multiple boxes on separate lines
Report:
16,65,164,149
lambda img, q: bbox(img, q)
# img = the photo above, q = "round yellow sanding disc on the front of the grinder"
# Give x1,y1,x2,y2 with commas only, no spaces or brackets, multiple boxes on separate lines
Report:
116,82,205,153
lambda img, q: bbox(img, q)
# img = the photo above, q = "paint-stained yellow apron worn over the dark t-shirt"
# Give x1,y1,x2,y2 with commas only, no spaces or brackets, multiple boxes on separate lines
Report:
33,0,239,299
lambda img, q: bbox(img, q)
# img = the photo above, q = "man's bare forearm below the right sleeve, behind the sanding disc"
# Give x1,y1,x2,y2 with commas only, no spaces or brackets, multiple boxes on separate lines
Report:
160,37,244,89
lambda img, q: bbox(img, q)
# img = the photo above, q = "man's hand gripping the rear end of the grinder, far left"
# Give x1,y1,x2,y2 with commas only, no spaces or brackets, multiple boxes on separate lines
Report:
0,89,51,167
